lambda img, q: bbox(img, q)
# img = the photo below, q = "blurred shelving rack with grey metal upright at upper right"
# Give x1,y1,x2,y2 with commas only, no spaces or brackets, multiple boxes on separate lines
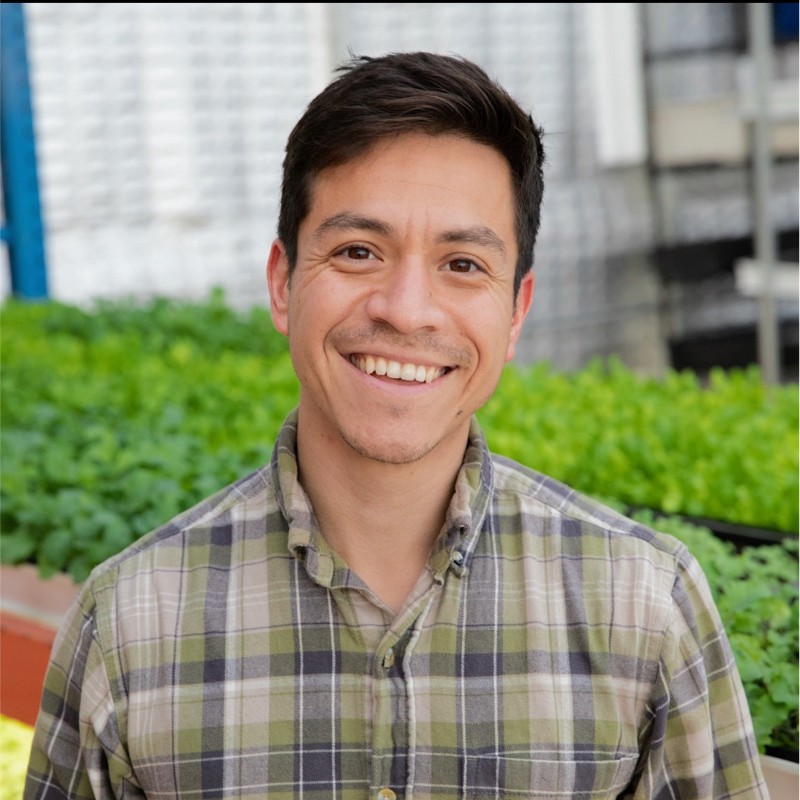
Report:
648,3,800,383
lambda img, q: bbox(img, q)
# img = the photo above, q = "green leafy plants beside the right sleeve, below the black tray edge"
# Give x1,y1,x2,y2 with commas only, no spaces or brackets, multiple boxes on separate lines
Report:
632,511,800,752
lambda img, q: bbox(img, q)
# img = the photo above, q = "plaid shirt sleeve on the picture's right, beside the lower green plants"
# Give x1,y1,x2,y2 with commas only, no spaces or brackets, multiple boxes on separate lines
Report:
633,550,769,800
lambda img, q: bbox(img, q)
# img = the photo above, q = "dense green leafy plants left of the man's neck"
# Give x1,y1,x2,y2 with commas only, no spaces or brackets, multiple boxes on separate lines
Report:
0,295,297,581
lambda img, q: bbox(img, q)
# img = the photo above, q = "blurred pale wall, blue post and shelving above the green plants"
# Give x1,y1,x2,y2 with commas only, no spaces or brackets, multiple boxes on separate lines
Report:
0,3,798,382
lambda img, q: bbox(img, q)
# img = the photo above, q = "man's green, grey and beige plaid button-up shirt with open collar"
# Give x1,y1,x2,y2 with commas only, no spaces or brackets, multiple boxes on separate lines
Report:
25,415,767,800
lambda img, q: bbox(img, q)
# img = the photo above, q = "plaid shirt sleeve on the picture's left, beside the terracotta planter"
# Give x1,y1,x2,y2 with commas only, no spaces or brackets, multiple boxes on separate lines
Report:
24,588,144,800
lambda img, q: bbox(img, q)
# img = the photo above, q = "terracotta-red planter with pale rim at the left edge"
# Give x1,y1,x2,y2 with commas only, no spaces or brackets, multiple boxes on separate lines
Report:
0,564,78,725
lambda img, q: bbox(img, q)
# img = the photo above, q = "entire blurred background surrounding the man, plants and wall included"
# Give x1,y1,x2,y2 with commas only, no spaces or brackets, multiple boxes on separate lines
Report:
0,9,800,800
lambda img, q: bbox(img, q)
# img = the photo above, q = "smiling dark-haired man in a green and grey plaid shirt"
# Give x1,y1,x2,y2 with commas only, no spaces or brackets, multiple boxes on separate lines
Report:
26,53,766,800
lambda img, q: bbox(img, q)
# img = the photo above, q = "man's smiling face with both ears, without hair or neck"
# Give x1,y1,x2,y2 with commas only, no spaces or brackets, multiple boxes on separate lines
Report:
268,134,533,464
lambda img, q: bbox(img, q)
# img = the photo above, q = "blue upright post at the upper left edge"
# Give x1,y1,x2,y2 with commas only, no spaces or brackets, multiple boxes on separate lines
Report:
0,3,48,300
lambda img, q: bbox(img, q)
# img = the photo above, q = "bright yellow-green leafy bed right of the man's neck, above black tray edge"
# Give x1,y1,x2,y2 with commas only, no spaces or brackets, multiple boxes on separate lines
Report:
479,359,798,532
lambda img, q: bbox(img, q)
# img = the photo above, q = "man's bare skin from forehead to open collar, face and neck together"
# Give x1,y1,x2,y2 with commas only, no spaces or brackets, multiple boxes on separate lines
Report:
269,133,533,612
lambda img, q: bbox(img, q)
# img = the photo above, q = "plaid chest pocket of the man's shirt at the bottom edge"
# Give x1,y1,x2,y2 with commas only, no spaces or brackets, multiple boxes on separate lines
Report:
465,754,637,800
